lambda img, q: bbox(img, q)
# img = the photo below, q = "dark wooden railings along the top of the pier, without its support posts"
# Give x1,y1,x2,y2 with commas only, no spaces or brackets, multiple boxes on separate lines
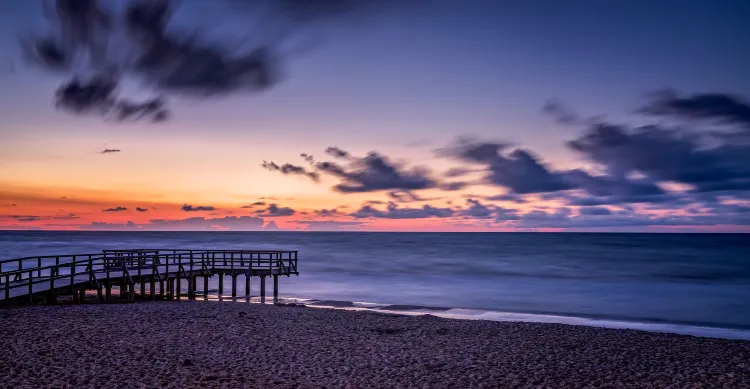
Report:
0,249,299,302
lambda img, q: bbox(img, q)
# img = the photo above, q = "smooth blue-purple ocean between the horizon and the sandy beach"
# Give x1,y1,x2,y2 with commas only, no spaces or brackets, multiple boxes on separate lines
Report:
0,231,750,339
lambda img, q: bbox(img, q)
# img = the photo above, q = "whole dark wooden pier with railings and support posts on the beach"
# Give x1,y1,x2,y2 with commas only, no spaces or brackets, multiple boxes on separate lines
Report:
0,249,299,305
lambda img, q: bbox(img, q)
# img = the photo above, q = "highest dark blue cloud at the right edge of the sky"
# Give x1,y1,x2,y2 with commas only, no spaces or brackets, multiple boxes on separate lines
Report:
637,89,750,126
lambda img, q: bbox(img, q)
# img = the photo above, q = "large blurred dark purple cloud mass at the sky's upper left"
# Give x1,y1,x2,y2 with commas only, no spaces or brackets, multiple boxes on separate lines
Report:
21,0,412,121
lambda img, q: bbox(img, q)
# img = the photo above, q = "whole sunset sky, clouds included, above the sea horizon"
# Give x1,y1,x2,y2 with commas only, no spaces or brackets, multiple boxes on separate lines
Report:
0,0,750,232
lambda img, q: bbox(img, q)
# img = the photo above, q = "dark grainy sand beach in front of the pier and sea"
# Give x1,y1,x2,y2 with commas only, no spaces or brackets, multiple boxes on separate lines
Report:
0,301,750,388
